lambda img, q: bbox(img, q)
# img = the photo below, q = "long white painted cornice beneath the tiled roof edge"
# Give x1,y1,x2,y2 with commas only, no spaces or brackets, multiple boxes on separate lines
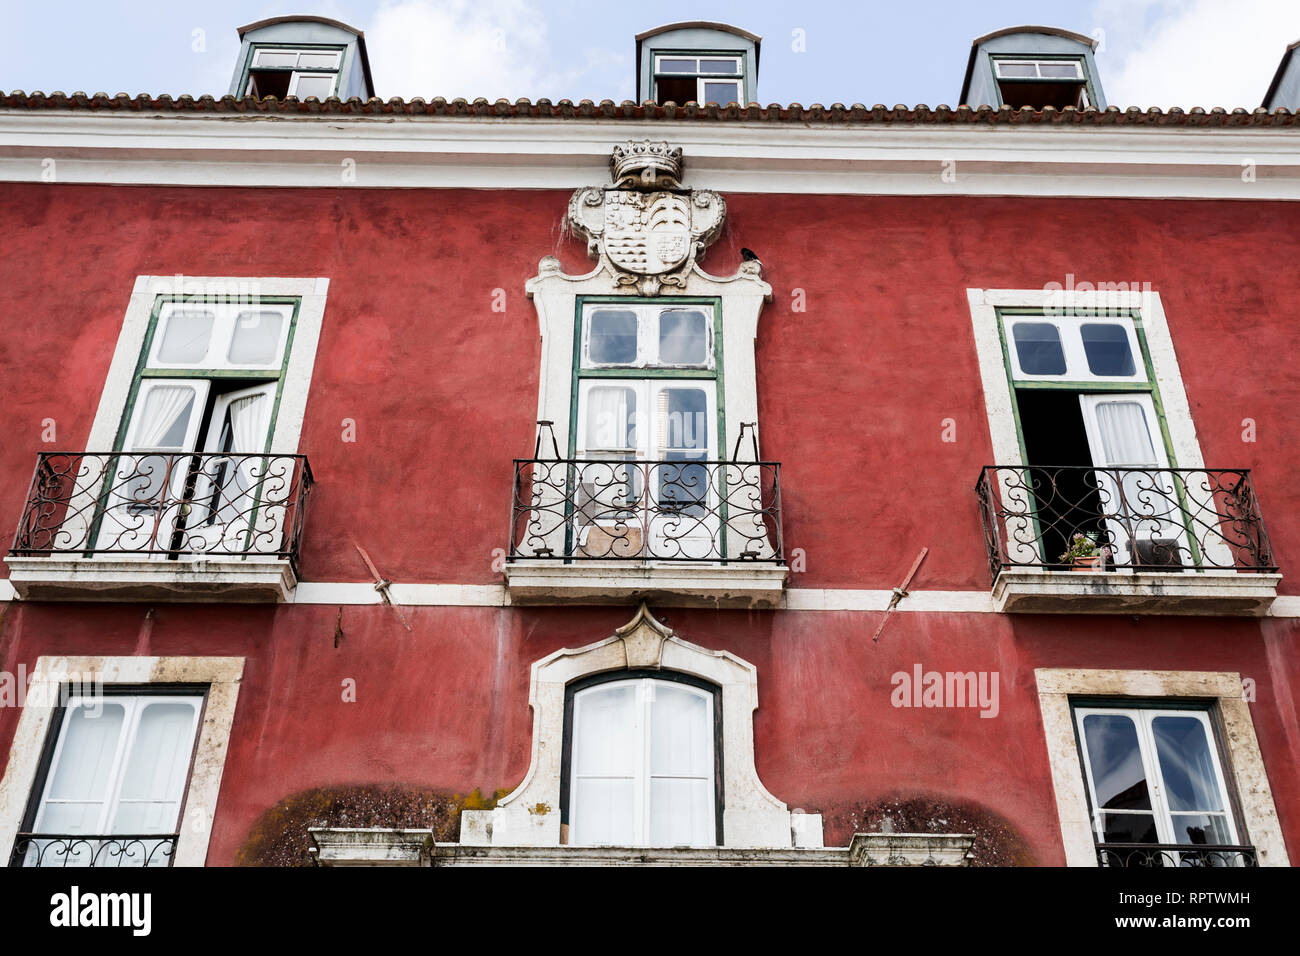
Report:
0,109,1300,199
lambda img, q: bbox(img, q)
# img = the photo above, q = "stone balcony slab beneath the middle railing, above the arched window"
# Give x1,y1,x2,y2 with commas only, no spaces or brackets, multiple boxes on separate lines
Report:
506,558,789,609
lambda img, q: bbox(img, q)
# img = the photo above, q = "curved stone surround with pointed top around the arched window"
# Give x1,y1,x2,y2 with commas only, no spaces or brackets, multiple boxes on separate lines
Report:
460,604,823,848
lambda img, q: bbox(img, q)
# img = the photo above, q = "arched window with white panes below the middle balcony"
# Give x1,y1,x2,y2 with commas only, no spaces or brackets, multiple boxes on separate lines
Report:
560,671,723,847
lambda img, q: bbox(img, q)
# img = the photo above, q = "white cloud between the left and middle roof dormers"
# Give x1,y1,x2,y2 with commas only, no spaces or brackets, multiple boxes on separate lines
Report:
365,0,627,100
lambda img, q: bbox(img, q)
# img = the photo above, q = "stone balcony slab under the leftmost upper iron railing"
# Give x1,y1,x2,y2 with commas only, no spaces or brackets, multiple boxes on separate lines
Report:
4,555,298,604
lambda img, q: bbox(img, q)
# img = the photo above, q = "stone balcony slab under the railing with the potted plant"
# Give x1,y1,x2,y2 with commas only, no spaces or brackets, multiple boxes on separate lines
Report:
993,570,1282,617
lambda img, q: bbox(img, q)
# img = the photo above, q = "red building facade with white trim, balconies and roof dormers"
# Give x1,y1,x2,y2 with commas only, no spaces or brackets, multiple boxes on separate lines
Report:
0,18,1300,866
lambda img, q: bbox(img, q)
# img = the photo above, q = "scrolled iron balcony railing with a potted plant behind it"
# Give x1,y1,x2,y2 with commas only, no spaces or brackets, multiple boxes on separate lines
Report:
975,464,1278,580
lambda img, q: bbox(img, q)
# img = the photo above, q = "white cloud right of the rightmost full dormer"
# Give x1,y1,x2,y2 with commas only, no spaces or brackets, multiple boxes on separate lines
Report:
1096,0,1300,109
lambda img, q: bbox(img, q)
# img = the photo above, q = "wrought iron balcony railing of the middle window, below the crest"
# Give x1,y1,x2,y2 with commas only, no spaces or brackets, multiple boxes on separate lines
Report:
510,459,785,564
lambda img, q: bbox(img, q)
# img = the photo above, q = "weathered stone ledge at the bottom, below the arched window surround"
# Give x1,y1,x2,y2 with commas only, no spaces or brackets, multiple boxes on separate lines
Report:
308,827,975,866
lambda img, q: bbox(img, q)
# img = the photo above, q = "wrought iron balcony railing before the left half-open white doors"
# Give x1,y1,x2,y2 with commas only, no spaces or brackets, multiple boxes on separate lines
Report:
9,451,312,571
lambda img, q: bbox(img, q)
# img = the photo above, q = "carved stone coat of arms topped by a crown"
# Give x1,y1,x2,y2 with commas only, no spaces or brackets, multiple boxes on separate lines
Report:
567,139,727,295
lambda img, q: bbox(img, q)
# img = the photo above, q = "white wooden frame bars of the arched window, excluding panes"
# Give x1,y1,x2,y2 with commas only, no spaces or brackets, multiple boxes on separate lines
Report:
568,678,718,847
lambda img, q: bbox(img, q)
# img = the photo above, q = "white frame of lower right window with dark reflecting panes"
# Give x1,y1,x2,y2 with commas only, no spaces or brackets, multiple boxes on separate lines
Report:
1074,705,1240,852
